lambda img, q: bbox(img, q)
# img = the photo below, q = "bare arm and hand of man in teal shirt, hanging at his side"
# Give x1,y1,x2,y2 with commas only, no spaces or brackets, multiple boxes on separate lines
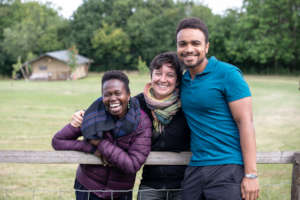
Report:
229,97,259,200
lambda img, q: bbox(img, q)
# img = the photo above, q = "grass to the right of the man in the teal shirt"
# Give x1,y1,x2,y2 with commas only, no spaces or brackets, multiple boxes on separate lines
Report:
246,76,300,200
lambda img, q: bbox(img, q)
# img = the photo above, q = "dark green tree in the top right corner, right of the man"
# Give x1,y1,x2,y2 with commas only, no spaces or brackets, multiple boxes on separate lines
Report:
225,0,300,73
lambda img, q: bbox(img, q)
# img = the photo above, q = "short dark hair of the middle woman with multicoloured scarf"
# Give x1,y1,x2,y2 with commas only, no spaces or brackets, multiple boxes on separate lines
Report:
150,52,183,83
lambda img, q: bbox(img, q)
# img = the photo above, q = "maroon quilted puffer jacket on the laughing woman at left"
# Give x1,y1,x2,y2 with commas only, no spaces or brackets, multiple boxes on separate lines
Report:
52,110,152,199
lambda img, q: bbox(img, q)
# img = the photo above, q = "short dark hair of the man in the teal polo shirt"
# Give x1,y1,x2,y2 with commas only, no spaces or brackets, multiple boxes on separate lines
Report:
176,17,208,43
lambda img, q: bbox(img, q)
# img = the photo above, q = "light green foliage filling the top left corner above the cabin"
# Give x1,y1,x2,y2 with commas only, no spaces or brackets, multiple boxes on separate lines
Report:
0,0,66,76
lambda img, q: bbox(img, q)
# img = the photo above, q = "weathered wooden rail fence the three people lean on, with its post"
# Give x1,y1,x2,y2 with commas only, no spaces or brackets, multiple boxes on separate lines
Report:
0,150,300,200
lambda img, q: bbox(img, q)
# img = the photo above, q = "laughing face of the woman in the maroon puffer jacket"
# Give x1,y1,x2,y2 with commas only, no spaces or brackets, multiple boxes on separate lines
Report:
102,79,130,118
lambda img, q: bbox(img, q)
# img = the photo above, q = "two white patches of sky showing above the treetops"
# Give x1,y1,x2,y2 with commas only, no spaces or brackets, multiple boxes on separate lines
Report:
38,0,243,18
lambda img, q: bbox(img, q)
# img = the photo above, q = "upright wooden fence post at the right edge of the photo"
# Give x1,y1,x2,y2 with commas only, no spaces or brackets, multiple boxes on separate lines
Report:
291,153,300,200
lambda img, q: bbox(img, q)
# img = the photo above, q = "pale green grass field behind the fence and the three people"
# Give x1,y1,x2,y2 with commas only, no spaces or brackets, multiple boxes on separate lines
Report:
0,73,300,200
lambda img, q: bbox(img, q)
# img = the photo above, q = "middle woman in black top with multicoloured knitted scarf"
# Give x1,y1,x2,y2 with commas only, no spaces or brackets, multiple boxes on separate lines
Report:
136,52,190,200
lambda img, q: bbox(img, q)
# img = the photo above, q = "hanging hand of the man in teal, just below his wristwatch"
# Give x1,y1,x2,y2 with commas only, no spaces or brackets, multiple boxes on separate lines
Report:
241,177,259,200
